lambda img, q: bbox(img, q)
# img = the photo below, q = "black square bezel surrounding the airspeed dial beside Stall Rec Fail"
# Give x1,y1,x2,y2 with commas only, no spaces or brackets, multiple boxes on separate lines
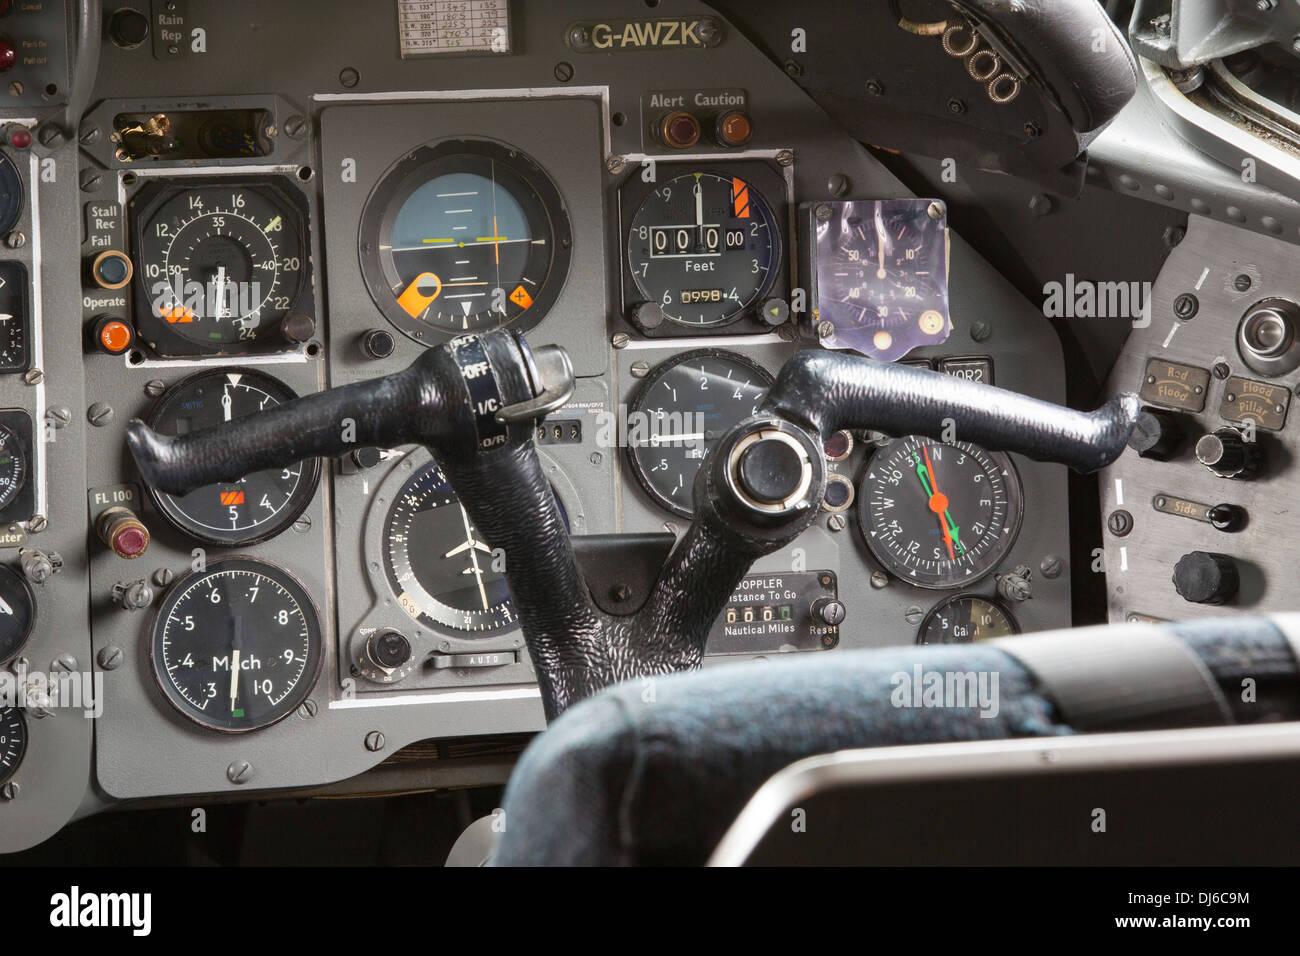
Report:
127,176,313,358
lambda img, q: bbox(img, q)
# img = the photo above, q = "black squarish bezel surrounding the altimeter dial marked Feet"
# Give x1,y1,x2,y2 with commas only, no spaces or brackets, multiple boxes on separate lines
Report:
620,170,787,336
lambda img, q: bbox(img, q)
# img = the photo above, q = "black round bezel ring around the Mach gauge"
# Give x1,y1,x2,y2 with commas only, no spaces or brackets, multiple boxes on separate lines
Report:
148,554,325,735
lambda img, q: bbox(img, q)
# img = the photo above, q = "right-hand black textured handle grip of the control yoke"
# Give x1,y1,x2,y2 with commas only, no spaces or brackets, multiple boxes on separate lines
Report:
763,351,1139,472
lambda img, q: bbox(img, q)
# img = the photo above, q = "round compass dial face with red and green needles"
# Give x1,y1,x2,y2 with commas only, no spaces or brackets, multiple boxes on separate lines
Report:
858,436,1024,588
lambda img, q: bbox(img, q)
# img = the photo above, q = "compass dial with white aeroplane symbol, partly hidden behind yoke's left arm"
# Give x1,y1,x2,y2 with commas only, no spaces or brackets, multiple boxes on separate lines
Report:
384,462,568,637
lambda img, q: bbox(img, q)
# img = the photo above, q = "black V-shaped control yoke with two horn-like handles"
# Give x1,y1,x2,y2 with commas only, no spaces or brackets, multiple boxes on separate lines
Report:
126,330,1139,719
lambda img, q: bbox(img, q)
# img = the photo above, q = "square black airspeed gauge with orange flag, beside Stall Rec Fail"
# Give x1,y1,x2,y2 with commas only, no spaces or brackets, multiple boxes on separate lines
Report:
130,177,309,356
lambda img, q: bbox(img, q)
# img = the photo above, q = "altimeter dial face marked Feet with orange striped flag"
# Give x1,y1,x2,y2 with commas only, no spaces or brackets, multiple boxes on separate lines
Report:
628,167,781,328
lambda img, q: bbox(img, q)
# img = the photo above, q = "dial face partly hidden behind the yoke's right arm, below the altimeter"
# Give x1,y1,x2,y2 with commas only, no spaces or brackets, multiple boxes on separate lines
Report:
627,349,772,518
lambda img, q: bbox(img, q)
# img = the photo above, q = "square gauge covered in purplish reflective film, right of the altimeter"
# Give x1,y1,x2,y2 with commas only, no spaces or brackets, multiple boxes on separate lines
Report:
805,199,953,362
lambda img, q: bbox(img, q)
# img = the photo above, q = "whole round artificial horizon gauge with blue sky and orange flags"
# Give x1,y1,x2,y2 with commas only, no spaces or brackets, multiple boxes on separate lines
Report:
359,139,572,345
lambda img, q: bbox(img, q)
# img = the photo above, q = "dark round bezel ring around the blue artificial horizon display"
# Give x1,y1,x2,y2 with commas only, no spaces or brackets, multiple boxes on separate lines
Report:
356,138,573,346
